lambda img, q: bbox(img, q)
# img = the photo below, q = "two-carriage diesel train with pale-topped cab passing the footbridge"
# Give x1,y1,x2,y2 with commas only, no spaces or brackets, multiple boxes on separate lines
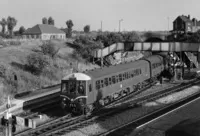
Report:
61,55,170,113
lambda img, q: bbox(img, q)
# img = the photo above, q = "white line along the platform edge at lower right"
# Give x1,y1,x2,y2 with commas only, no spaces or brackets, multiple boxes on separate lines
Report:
136,94,200,129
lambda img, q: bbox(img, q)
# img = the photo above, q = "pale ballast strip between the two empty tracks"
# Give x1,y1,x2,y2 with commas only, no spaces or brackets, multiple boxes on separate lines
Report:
63,86,200,136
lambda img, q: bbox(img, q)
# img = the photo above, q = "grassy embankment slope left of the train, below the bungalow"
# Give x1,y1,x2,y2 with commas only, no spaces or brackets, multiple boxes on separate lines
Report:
0,40,96,105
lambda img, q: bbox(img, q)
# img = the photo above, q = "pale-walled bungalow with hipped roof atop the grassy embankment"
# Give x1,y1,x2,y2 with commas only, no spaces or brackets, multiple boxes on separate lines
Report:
23,24,65,40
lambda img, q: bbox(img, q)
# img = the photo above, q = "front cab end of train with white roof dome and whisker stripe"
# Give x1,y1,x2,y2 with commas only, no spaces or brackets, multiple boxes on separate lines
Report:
61,73,91,114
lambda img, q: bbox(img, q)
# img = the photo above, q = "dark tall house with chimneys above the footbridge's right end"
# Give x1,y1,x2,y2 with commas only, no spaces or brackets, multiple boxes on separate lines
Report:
173,15,200,33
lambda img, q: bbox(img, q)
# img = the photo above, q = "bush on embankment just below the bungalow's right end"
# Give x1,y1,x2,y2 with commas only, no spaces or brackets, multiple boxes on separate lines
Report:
40,41,60,58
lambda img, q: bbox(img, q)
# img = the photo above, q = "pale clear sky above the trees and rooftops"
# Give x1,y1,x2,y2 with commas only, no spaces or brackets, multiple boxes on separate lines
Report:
0,0,200,31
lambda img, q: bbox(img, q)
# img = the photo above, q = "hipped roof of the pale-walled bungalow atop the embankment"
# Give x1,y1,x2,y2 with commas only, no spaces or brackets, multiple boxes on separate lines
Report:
23,24,65,34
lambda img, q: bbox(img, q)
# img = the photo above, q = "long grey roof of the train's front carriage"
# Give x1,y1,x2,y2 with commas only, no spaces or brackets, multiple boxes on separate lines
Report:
84,60,148,78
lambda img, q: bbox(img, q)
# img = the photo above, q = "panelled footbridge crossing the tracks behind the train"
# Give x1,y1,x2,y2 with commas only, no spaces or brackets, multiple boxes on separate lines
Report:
93,42,200,67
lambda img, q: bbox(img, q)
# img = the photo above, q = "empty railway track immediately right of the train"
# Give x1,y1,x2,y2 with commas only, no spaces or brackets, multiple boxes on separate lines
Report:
20,78,200,136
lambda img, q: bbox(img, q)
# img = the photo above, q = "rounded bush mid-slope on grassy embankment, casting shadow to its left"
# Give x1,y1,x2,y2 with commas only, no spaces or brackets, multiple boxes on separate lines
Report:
26,53,49,74
